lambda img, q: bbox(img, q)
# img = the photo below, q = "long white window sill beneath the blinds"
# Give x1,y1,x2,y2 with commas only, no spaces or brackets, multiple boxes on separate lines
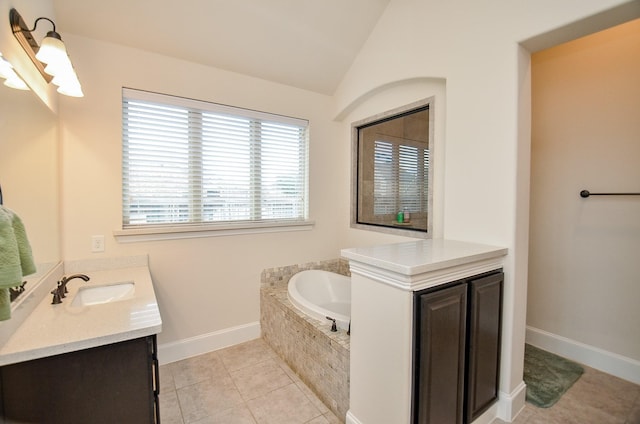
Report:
113,221,315,243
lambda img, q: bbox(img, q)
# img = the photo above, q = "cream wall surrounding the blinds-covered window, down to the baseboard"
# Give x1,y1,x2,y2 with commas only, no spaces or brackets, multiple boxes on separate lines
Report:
60,35,345,361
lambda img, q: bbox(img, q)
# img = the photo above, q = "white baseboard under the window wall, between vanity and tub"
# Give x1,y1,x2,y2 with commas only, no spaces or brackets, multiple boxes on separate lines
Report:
158,321,260,365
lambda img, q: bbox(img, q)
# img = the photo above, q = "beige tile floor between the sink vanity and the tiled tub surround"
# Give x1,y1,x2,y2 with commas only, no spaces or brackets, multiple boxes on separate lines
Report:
160,339,342,424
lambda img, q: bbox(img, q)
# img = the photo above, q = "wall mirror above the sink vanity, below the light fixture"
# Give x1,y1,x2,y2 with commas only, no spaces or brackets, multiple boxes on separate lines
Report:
0,84,60,289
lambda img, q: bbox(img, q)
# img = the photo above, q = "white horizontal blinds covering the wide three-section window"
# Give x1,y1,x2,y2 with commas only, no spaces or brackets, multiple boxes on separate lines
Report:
122,89,308,228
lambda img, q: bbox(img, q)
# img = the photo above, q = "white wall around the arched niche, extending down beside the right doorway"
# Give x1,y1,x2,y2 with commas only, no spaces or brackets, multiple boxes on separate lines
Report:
334,0,640,417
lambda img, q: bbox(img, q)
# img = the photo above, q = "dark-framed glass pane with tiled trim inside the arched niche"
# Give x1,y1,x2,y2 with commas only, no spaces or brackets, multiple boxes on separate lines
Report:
351,98,433,238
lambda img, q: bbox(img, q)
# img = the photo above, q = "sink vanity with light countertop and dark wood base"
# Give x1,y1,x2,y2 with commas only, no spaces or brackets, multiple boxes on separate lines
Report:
0,256,162,424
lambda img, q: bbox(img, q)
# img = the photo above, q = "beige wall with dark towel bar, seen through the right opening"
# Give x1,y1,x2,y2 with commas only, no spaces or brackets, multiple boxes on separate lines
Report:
527,20,640,379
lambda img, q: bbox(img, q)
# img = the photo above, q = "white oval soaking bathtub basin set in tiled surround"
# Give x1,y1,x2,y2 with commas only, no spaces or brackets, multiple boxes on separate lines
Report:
287,270,351,330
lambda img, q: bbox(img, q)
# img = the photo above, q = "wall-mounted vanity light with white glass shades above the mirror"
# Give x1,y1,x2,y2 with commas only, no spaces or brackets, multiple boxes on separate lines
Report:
9,9,84,97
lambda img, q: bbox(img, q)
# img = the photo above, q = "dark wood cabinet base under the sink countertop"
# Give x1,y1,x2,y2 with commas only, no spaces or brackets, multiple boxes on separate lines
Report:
0,335,160,424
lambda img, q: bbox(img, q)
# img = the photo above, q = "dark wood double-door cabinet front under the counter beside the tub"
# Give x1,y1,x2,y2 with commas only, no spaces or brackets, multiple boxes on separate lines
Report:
412,271,504,424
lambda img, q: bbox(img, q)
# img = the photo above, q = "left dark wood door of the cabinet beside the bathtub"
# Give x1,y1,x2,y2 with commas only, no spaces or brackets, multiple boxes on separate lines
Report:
413,284,467,424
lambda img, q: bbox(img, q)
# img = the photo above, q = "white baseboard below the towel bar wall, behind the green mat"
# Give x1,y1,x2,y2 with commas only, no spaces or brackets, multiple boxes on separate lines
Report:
526,326,640,384
